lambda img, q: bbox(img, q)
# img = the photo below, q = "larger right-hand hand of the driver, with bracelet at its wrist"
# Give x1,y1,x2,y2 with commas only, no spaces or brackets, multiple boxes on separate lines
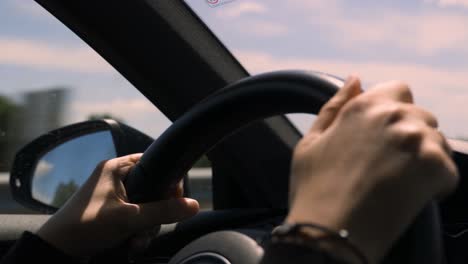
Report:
287,77,458,263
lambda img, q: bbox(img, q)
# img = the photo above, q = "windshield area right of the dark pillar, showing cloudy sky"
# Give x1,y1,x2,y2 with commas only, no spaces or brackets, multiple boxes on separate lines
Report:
186,0,468,138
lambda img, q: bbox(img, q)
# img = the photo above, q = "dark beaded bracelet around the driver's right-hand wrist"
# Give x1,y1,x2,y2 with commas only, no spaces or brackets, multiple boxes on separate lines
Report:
271,223,369,264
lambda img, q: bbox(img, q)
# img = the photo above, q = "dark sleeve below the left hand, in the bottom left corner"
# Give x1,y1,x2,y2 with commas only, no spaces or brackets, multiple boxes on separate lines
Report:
0,232,80,264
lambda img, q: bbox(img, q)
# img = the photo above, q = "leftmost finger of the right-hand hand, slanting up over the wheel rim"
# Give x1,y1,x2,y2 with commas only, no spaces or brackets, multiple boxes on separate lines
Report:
310,76,362,134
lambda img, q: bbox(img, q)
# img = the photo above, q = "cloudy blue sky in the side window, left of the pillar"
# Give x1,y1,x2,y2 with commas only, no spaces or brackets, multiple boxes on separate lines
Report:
0,0,170,137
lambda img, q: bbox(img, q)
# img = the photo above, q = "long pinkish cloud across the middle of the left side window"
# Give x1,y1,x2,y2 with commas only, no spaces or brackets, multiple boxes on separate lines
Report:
0,38,115,73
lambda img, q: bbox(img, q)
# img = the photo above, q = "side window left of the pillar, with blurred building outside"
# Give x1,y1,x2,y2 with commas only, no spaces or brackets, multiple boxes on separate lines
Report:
0,0,211,213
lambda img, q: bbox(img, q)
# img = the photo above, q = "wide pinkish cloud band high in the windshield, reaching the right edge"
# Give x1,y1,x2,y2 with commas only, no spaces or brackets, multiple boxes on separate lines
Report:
324,13,468,56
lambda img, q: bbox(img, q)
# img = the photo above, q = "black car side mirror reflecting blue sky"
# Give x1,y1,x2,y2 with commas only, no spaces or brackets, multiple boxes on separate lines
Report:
10,119,153,213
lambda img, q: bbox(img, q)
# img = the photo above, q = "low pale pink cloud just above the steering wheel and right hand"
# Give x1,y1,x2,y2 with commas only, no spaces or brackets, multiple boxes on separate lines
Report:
234,50,468,136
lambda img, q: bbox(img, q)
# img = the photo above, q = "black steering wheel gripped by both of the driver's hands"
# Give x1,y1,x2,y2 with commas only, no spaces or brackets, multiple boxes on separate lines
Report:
124,71,443,264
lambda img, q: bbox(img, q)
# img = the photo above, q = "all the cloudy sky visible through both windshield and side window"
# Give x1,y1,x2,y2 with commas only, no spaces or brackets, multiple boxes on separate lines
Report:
0,0,468,137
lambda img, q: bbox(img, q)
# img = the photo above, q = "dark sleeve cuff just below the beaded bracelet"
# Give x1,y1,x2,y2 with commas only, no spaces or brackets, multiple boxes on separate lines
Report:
260,243,347,264
